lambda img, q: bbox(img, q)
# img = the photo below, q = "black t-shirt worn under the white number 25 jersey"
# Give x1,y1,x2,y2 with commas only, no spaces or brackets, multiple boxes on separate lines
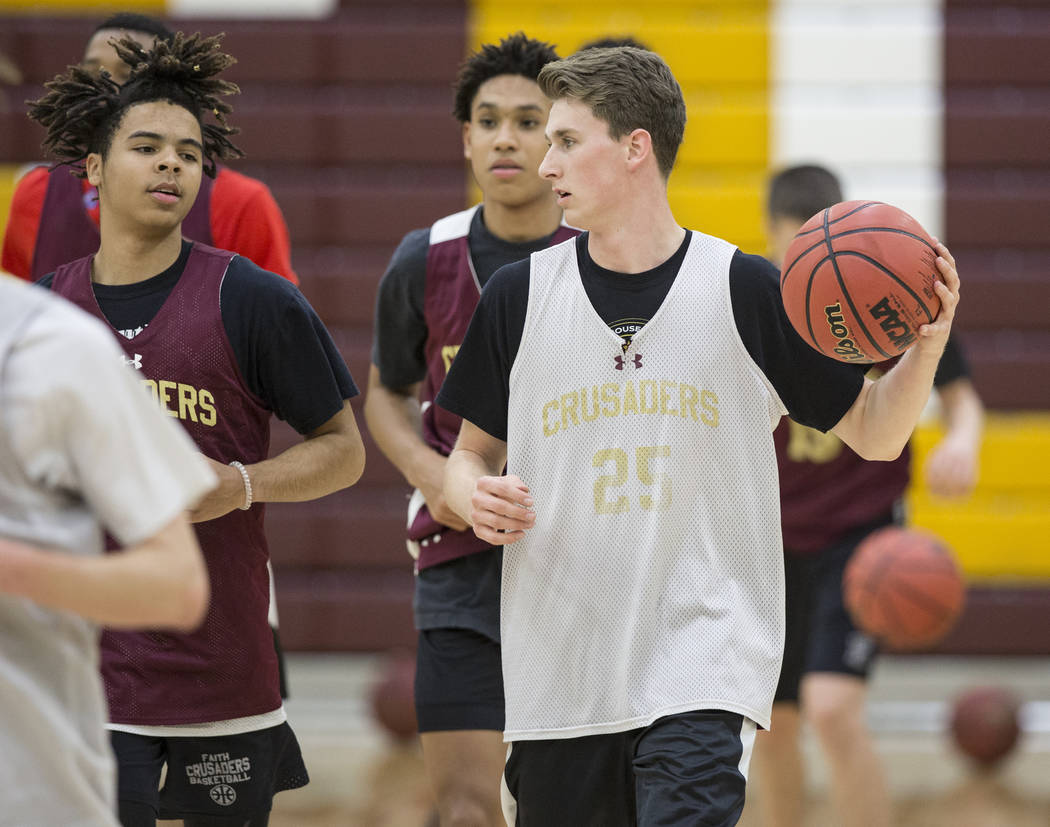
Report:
437,232,864,440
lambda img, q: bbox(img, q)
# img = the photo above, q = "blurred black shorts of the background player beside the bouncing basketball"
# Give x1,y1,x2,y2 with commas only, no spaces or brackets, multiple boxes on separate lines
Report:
775,514,895,703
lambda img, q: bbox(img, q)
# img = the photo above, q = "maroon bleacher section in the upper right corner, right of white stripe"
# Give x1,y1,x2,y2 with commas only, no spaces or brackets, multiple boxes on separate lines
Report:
944,0,1050,408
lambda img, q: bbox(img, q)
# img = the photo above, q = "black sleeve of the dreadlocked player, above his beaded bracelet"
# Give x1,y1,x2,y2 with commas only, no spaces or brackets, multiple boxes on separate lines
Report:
221,256,358,433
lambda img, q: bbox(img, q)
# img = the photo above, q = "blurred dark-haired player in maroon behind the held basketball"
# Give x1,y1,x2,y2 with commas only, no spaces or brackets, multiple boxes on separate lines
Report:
755,166,983,827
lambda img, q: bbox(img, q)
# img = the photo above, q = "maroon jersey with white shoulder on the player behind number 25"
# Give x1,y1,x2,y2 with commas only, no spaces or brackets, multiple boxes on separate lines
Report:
408,209,580,569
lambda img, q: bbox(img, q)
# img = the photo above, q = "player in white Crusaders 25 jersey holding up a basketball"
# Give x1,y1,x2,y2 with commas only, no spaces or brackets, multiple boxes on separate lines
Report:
438,47,959,825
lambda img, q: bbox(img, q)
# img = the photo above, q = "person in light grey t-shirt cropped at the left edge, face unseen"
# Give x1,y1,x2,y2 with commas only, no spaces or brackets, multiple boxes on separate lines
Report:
0,274,215,827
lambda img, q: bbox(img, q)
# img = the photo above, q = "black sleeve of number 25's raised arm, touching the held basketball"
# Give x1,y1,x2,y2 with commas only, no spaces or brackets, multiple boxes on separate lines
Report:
730,251,868,431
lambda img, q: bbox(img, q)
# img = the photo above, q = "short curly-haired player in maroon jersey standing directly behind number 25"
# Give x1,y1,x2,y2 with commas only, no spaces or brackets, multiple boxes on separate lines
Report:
364,33,575,826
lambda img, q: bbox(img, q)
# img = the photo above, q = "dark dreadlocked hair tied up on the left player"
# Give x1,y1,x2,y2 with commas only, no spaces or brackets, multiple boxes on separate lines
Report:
27,31,244,177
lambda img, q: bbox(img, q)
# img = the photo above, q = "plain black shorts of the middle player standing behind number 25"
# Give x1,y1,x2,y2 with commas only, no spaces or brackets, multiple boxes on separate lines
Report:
416,629,504,733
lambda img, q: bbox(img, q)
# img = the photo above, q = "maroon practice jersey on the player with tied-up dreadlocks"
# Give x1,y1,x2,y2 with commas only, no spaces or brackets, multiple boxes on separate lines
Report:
51,243,281,725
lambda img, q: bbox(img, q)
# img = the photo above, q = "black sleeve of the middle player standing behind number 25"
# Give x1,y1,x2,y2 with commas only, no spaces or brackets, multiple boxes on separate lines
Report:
372,229,431,388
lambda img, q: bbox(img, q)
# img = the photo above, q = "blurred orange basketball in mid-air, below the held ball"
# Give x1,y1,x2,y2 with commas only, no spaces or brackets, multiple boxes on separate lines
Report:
842,526,966,649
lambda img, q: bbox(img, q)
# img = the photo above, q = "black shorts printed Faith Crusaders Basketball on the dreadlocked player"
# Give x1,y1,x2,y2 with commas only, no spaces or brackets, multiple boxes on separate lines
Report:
109,722,310,819
